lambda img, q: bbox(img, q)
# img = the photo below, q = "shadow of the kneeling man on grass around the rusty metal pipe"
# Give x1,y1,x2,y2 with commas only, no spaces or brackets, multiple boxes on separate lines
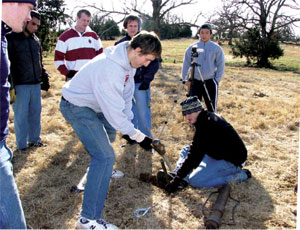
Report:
176,177,274,229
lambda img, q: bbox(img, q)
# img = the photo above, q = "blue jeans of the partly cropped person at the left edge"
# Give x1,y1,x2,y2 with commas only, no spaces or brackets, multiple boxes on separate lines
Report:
0,141,26,229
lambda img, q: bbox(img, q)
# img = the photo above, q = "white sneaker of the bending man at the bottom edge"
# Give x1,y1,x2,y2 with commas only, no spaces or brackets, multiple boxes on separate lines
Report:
76,217,118,230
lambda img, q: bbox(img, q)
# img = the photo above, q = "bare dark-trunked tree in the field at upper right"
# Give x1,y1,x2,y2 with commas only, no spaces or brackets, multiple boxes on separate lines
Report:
216,0,300,67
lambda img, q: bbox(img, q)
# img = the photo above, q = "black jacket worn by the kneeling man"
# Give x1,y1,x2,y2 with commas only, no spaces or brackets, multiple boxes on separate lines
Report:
177,110,247,178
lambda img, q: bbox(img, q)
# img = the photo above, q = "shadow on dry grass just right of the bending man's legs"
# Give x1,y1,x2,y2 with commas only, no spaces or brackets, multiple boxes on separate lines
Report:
104,144,166,229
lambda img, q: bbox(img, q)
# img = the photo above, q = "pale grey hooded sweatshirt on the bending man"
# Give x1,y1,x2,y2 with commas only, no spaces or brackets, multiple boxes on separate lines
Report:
62,42,137,136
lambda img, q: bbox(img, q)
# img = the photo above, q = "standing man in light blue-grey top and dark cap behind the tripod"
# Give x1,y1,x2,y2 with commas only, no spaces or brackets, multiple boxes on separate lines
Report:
181,24,225,112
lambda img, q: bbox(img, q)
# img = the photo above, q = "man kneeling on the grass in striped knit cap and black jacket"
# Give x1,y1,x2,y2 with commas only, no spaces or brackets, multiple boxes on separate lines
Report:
157,96,251,193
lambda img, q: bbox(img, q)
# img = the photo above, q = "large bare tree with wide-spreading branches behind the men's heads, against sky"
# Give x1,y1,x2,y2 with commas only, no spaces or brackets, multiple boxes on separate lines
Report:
71,0,201,34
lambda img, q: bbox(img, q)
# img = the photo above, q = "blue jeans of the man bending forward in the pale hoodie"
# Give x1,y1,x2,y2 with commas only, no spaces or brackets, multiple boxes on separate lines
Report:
60,100,116,220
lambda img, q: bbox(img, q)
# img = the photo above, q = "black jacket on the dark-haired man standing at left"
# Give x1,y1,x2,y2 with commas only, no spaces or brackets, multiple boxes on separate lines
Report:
6,32,48,86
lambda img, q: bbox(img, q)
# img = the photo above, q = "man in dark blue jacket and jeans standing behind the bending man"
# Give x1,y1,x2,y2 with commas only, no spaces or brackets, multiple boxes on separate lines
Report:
115,15,159,137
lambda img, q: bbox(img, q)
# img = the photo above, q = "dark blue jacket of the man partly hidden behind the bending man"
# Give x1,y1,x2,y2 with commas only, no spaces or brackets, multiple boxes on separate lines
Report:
115,33,159,87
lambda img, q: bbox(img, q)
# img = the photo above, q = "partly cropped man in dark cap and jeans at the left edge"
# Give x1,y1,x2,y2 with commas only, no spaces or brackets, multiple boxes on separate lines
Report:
0,0,36,229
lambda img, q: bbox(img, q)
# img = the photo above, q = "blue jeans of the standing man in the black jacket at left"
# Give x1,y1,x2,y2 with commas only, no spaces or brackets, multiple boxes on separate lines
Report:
13,84,42,149
